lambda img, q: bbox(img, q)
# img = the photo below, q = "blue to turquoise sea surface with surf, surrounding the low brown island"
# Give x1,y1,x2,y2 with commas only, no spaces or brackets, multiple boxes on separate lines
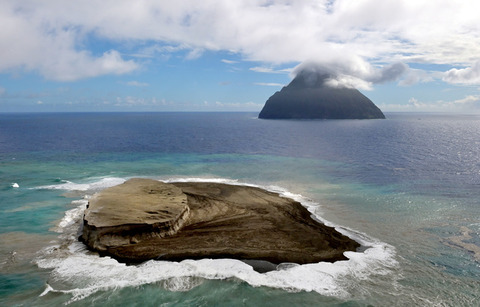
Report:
0,113,480,307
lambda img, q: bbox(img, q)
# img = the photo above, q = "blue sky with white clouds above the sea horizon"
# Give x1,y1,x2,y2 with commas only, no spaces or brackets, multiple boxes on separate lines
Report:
0,0,480,114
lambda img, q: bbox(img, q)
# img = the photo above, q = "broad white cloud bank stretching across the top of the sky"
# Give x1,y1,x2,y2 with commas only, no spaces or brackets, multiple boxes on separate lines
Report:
0,0,480,82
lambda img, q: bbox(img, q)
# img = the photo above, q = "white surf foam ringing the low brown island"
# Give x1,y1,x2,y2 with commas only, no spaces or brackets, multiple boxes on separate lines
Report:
36,178,398,301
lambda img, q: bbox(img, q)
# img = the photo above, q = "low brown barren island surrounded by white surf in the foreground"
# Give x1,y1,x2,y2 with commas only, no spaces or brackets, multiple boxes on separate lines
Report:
80,178,360,264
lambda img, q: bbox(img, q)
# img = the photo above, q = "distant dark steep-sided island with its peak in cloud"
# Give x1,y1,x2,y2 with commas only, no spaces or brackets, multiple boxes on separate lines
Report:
258,72,385,119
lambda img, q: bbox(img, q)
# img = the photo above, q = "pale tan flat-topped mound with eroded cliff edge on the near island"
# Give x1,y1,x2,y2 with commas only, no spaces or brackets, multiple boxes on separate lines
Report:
82,179,190,252
